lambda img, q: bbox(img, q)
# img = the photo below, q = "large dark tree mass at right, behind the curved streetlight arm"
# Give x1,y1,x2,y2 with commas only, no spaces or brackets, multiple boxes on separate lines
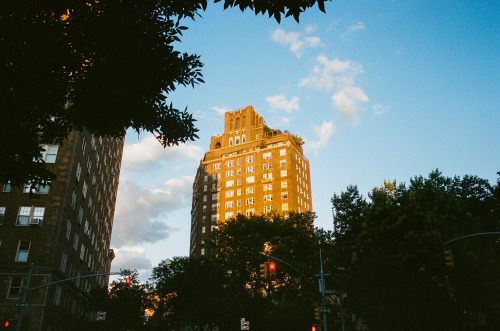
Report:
332,170,500,330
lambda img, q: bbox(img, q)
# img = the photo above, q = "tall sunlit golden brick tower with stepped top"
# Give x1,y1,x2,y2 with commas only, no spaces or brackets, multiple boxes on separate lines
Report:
190,106,312,256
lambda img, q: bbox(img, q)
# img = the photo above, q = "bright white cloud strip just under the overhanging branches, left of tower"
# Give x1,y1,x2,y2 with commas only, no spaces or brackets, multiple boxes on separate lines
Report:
123,134,204,166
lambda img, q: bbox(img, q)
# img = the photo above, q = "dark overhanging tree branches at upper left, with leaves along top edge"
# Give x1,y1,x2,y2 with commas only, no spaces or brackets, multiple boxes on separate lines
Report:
0,0,325,185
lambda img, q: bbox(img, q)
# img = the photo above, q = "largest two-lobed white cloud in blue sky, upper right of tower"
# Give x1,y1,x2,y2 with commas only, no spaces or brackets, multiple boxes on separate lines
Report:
299,55,368,123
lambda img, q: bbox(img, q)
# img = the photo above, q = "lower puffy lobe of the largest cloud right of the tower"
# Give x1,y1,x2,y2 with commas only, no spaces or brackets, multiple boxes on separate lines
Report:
332,86,368,123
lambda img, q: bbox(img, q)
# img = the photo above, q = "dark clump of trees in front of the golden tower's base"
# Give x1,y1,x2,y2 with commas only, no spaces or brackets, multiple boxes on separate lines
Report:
151,213,332,331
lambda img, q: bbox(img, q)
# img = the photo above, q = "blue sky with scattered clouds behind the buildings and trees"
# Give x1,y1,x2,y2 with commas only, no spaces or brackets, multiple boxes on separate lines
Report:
107,0,500,281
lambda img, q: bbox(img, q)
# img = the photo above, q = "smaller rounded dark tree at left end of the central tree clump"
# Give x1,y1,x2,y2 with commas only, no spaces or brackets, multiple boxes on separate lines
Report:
151,257,239,330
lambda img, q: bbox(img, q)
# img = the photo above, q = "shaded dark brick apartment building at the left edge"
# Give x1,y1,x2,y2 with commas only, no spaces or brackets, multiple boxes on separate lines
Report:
0,132,123,331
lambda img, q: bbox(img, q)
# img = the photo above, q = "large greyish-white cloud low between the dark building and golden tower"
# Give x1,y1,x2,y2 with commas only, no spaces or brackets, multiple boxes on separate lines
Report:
112,176,194,248
